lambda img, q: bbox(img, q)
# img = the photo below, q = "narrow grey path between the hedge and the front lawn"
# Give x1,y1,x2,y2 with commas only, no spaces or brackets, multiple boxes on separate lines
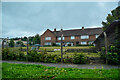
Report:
2,60,120,69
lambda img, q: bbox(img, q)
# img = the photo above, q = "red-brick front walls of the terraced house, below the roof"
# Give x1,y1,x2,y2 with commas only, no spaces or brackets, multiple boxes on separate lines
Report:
41,29,96,46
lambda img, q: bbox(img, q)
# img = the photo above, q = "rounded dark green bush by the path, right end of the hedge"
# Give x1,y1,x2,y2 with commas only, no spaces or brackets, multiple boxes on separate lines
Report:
73,54,87,64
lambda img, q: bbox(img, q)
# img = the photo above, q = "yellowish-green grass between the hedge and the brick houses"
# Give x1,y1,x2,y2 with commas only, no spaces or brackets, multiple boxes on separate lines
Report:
8,46,100,58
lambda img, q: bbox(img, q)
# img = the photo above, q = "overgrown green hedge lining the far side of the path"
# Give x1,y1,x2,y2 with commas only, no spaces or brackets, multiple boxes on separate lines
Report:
2,48,87,64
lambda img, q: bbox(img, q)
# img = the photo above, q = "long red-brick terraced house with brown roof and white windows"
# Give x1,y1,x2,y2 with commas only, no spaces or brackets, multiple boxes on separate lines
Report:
41,27,102,46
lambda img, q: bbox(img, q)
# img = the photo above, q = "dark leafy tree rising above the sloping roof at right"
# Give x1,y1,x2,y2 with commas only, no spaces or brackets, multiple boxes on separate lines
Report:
102,6,120,30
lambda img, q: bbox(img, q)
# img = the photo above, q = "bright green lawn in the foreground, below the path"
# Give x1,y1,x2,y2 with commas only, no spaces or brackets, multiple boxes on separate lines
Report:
2,63,120,80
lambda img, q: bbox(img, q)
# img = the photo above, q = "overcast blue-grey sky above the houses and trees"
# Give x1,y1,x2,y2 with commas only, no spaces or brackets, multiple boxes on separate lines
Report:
2,2,118,37
